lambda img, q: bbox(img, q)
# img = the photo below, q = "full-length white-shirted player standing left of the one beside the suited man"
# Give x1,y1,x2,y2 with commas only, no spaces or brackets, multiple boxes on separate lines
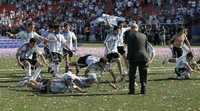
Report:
104,26,124,82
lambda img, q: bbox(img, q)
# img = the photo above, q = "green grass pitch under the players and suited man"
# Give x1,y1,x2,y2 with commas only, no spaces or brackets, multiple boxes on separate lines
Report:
0,58,200,111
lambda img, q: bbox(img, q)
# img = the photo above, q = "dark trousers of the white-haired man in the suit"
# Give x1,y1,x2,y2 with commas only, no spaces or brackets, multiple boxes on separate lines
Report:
129,61,148,93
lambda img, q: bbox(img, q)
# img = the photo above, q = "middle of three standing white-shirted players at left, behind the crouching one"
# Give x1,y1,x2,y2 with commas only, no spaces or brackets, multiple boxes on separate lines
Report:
47,24,71,76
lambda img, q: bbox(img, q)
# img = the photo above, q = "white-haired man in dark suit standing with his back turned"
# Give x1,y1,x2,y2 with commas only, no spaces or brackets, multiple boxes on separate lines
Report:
125,23,148,94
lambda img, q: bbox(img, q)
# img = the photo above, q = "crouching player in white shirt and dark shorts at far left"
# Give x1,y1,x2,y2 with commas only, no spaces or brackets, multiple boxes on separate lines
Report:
16,38,46,85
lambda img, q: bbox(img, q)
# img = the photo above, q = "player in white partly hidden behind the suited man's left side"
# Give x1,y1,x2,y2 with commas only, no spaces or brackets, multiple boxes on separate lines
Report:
117,21,131,69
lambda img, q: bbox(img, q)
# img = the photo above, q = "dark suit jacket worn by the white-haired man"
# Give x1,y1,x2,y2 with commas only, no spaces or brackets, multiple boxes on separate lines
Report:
125,31,148,62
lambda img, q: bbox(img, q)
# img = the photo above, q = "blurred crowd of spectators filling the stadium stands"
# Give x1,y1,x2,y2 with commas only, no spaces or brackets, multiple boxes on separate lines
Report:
0,0,200,44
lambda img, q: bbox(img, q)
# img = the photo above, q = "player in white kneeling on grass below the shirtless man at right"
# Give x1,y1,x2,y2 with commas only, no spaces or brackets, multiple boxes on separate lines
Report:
175,52,194,80
